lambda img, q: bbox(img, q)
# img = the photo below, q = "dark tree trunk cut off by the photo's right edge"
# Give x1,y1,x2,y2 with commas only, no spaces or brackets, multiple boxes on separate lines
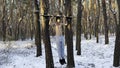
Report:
113,0,120,67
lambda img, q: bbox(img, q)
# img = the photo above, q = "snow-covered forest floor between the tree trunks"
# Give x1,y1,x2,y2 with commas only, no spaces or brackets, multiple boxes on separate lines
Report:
0,36,115,68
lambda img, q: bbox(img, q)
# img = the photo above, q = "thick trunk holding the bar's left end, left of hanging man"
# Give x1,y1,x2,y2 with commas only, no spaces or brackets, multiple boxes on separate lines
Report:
42,0,54,68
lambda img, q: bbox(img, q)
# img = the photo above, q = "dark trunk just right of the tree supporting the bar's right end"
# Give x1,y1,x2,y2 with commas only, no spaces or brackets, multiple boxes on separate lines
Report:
76,0,83,55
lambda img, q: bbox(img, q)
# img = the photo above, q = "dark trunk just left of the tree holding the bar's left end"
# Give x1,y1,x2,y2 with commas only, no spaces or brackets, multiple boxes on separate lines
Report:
34,0,42,57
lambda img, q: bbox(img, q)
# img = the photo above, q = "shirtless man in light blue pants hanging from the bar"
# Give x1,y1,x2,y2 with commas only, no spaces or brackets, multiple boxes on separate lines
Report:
55,16,66,65
